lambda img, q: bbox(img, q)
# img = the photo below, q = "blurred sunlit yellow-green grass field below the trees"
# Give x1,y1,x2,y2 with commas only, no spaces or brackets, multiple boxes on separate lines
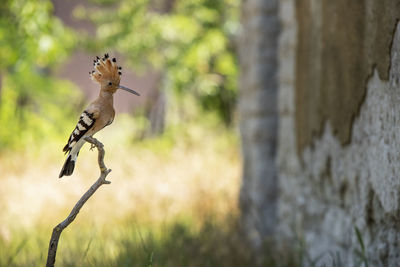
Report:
0,116,246,266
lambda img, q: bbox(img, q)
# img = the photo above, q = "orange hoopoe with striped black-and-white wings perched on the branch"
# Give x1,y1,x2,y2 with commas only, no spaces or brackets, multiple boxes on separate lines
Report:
59,54,140,178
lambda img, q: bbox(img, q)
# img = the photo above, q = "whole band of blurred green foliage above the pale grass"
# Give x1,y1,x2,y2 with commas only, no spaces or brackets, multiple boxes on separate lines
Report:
0,0,238,151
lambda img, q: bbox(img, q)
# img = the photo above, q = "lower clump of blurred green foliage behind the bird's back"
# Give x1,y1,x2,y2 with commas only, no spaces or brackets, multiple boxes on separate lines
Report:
0,72,79,152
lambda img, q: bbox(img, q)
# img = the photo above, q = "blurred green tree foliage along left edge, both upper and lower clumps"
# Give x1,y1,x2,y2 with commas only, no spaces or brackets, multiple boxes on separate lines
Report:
0,0,79,150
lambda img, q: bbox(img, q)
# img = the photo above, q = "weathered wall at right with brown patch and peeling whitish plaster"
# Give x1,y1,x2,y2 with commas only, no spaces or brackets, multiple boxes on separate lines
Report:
277,0,400,266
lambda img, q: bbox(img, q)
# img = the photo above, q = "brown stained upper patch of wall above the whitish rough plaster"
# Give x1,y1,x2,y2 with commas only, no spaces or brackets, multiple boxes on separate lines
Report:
295,0,400,151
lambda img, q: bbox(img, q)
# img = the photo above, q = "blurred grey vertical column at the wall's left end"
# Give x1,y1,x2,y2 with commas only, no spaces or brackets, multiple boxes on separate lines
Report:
239,0,279,248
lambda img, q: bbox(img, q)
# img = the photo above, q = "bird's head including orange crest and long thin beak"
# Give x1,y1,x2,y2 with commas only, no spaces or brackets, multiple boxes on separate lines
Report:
89,54,140,96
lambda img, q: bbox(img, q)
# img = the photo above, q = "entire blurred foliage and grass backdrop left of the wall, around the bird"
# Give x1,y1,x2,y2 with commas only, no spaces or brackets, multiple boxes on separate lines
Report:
0,0,264,266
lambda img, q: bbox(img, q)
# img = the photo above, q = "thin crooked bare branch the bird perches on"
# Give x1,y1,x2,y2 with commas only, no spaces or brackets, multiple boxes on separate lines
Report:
46,137,111,267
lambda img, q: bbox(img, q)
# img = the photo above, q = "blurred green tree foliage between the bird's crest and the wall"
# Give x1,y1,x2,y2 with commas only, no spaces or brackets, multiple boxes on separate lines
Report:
76,0,239,124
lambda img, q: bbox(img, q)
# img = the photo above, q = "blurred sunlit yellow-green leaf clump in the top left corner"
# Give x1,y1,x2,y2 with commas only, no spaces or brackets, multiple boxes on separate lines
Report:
0,0,75,68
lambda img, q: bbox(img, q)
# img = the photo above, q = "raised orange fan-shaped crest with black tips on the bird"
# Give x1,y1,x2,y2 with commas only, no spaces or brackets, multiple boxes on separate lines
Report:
89,54,122,85
